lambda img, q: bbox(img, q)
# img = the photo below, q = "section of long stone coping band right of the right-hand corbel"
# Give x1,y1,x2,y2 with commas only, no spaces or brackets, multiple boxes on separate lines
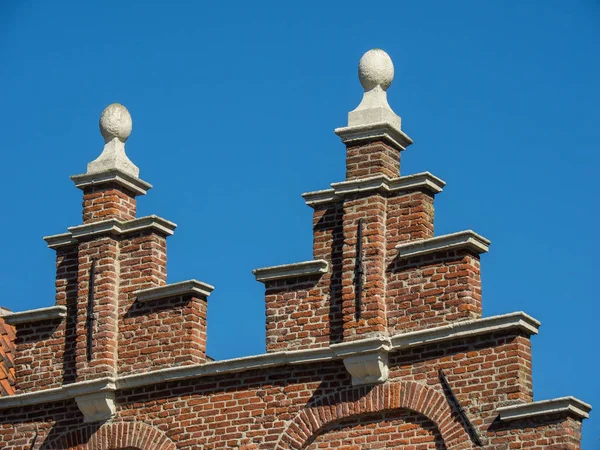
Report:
390,311,541,350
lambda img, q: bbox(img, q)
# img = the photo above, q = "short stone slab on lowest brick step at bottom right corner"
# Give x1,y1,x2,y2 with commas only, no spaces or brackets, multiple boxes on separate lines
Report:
496,396,592,422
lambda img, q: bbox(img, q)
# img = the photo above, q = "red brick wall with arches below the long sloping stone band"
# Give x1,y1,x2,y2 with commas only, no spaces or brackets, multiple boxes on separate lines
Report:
0,333,580,450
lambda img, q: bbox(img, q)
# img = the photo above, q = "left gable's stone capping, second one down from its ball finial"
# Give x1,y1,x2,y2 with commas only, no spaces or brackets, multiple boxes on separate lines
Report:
44,215,177,249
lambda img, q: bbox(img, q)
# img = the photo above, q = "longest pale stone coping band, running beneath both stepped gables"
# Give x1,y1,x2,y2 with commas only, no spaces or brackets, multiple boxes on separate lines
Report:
0,312,540,410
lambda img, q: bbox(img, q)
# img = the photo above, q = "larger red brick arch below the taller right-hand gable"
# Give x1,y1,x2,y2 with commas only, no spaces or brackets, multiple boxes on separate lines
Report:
276,381,473,450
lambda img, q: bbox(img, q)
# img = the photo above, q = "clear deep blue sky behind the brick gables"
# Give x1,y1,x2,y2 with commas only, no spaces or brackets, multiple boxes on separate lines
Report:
0,0,600,450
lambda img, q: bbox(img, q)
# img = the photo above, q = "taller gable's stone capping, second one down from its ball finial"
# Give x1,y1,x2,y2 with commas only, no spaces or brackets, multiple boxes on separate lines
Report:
302,172,446,206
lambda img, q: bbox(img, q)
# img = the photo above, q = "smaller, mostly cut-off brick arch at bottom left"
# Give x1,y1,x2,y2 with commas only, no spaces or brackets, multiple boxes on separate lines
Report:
41,422,177,450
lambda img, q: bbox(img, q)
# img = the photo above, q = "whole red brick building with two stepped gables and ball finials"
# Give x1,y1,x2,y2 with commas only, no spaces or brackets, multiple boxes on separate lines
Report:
0,50,591,450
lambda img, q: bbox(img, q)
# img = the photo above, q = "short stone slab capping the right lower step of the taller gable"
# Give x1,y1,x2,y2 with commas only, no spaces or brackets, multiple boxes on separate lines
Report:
396,230,491,259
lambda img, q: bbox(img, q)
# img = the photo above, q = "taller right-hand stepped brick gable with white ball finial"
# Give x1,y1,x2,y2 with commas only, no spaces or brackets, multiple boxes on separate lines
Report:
255,49,489,351
